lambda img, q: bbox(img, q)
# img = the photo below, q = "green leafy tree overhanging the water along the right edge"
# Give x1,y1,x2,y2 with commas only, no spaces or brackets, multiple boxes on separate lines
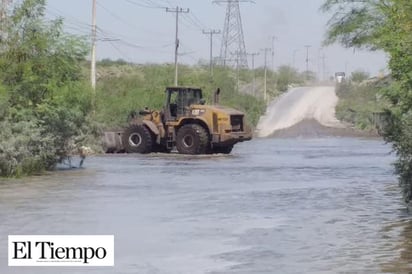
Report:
322,0,412,206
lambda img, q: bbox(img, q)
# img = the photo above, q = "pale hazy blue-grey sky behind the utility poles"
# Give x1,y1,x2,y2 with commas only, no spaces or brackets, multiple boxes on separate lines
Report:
47,0,386,75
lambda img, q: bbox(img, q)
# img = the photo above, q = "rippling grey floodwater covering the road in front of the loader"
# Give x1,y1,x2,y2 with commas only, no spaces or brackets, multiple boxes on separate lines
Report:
0,137,412,274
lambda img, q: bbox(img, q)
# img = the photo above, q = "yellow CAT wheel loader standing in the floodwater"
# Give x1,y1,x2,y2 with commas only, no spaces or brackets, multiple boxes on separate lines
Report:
105,87,252,155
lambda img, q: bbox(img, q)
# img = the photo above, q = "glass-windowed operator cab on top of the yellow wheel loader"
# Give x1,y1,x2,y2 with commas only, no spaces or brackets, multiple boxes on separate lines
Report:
164,87,204,120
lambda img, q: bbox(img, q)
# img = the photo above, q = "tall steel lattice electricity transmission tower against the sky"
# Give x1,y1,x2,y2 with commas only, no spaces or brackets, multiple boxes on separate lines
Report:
213,0,251,68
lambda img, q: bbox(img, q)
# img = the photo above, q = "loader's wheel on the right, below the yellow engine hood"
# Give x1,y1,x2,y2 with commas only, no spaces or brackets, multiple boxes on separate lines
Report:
176,124,210,155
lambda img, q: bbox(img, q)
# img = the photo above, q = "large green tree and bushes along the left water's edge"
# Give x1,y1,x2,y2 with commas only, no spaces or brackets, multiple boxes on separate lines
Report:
0,0,91,176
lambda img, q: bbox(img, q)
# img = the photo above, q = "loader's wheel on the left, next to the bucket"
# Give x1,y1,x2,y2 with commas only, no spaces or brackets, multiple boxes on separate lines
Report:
122,125,154,154
